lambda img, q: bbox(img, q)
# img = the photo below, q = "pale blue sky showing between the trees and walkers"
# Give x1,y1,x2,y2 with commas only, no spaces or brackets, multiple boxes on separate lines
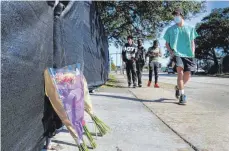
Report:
109,1,229,66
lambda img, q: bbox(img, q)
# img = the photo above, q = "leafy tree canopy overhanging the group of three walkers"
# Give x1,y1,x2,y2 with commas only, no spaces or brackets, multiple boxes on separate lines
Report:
96,1,205,47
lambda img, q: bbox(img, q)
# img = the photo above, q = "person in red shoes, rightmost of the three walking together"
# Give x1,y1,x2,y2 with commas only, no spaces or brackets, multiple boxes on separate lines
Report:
146,40,161,88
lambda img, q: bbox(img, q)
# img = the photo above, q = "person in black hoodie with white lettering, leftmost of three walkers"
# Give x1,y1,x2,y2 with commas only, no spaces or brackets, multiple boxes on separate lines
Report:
122,36,137,88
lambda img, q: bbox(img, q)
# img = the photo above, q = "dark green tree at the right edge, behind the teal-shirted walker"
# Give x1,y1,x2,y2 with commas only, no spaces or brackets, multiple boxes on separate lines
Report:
196,7,229,71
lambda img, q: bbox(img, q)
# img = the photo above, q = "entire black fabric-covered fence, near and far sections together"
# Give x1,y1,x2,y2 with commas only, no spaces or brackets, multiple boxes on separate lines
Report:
1,1,109,151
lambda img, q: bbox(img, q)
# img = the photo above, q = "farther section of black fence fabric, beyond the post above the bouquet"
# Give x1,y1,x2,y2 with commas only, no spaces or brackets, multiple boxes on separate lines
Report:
54,1,109,89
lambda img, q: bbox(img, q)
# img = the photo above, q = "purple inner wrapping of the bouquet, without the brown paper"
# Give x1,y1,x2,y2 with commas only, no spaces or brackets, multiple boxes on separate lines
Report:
50,68,84,142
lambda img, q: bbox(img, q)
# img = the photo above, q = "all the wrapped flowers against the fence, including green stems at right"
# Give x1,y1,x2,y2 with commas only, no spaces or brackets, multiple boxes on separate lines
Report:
44,64,110,151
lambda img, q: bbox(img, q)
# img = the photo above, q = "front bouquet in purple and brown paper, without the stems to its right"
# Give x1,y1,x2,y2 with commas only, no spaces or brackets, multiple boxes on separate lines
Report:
45,65,88,151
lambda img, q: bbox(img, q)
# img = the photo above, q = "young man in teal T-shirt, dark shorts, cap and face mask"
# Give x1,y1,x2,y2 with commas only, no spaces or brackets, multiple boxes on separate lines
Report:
164,8,198,104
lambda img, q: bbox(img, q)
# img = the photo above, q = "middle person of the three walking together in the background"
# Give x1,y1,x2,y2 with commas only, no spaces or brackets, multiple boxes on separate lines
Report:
136,39,146,87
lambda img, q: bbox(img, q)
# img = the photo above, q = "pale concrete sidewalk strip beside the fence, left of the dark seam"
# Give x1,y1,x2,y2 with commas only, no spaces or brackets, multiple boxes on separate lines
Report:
46,84,193,151
